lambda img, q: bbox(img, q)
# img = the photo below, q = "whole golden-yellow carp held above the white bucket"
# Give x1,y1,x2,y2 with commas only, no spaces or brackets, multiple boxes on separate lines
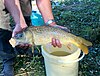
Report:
10,26,92,54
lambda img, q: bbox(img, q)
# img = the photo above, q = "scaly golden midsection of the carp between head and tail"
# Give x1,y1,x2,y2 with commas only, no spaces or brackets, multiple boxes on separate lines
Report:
29,26,72,45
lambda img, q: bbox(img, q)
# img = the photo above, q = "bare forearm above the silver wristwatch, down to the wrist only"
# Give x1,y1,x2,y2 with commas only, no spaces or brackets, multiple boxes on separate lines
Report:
36,0,54,23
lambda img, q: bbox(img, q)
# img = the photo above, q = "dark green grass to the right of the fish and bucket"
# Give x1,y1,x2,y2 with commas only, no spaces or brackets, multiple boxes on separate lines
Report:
53,0,100,76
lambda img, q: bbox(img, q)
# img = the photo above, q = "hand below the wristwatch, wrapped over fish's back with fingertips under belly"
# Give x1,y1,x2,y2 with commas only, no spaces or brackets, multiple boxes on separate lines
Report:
52,25,70,48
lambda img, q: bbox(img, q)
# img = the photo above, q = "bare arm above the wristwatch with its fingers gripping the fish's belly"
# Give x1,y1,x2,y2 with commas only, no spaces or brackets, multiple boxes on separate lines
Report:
36,0,61,47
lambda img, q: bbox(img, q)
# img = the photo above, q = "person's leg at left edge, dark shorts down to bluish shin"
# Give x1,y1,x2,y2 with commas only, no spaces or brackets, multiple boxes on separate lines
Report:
0,29,16,76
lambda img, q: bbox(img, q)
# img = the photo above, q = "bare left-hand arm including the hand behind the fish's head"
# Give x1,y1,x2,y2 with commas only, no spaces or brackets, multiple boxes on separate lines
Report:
4,0,27,36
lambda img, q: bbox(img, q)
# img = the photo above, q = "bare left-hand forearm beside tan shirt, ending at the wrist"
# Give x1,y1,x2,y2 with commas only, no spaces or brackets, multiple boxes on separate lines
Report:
4,0,25,28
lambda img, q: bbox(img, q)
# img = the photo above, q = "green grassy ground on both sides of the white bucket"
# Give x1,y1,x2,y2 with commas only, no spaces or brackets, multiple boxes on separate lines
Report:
0,0,100,76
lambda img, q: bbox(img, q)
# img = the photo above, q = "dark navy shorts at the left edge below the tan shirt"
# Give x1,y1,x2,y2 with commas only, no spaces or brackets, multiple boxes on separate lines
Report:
0,28,16,59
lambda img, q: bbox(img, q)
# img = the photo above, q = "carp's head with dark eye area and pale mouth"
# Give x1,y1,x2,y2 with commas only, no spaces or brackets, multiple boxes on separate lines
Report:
9,31,33,47
